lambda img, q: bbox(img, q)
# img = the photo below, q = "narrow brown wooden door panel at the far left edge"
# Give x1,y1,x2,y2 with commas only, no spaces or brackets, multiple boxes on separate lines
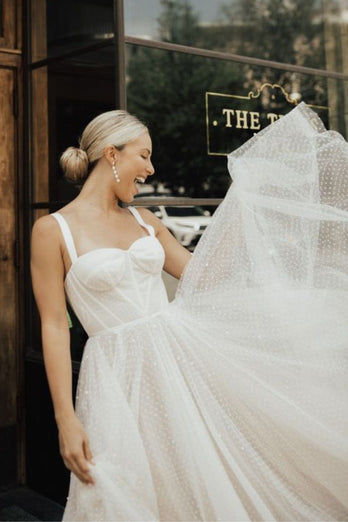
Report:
0,67,18,484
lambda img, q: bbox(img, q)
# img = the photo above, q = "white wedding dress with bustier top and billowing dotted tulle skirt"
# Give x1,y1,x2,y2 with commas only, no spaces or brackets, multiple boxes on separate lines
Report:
53,104,348,521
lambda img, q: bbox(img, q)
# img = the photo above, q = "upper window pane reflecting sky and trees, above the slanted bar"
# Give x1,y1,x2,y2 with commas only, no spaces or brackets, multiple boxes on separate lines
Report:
125,0,348,72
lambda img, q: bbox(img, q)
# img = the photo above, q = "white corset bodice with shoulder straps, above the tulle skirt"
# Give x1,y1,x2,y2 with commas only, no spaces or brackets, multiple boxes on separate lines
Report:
52,208,168,336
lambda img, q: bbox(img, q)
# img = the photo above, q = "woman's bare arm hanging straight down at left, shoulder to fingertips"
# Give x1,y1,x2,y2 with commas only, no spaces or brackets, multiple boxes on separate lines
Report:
31,216,93,483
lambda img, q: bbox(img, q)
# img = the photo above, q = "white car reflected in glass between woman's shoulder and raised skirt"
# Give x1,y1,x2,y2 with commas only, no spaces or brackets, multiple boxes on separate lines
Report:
150,205,211,248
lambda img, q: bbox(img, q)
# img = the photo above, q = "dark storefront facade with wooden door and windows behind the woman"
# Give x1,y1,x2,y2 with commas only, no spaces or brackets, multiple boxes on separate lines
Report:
0,0,348,503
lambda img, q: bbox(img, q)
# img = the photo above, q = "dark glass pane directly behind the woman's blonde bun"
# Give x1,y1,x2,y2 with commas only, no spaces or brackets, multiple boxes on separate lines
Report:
32,45,115,202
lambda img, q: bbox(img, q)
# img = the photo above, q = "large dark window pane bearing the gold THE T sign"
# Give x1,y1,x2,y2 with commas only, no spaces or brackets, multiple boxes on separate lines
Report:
127,46,347,197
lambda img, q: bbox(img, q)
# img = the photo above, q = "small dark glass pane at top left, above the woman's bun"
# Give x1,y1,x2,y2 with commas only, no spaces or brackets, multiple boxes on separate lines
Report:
31,0,114,62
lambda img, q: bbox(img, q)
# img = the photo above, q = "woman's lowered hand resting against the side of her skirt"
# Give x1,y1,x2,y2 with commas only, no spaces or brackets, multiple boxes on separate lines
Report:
58,415,95,484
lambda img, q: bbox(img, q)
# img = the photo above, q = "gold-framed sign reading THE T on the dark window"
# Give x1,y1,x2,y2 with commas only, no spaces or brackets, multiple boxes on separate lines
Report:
205,83,329,156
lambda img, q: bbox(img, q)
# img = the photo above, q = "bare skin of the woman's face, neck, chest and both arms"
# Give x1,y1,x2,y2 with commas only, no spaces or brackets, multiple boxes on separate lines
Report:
31,132,191,484
